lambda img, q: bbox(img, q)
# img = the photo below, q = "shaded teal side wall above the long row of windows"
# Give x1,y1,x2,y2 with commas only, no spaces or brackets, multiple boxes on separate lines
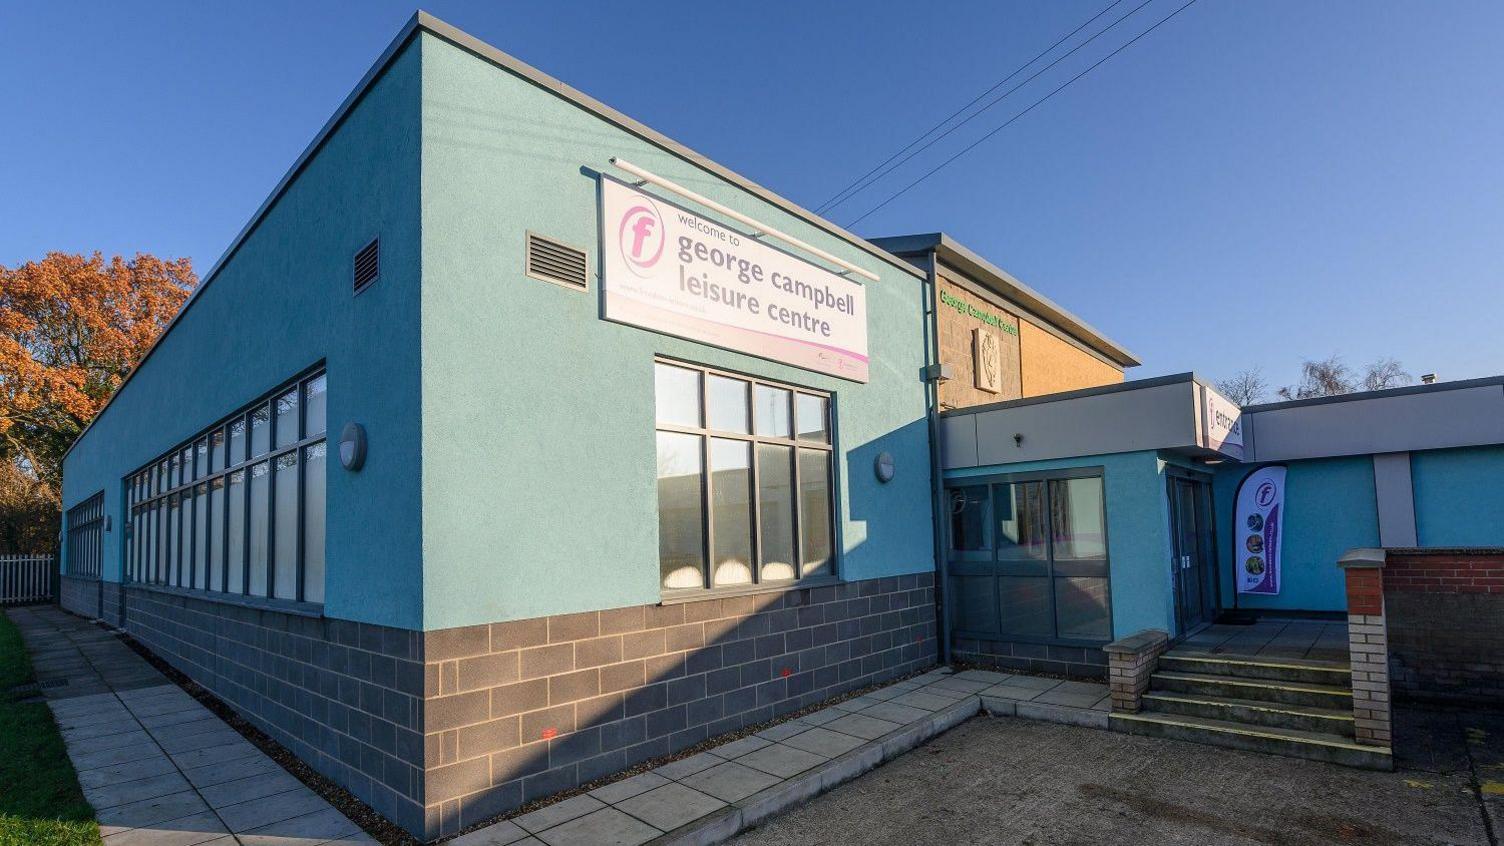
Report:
63,45,423,628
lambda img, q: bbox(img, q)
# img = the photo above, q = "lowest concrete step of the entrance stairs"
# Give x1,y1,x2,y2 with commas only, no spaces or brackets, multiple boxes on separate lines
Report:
1110,712,1394,771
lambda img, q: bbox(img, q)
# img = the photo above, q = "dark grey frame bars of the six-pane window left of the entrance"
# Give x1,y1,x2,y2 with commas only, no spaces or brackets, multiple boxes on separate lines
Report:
943,465,1114,647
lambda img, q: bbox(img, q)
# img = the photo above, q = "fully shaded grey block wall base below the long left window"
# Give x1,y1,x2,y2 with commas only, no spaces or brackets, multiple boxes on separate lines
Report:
125,586,426,832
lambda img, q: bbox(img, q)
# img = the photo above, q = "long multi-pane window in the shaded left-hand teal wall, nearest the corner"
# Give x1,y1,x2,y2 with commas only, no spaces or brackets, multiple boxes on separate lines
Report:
126,372,326,602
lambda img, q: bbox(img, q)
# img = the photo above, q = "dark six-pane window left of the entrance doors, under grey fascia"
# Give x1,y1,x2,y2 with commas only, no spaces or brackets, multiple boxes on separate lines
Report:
946,470,1111,643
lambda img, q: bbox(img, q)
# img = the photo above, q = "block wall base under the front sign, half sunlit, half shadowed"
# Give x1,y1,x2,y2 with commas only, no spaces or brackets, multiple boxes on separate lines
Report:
423,574,935,837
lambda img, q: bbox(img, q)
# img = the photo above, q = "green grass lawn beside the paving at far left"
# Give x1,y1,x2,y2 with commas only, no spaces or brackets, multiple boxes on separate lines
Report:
0,614,99,846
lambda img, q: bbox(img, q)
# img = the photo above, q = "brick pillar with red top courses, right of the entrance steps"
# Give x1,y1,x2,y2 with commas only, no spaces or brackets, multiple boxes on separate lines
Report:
1337,549,1393,748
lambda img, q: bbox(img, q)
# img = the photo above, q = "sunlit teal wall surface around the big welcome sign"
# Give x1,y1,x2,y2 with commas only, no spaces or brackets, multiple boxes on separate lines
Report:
420,35,934,629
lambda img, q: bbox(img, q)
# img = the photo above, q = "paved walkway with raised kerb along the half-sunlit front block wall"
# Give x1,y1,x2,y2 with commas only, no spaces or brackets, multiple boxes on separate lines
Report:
450,668,1107,846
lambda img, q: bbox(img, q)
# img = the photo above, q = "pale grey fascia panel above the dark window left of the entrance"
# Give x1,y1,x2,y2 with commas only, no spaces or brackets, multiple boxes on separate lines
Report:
972,379,1197,465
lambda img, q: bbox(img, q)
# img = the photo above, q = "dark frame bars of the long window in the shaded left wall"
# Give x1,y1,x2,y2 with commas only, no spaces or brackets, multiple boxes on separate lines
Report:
120,361,329,608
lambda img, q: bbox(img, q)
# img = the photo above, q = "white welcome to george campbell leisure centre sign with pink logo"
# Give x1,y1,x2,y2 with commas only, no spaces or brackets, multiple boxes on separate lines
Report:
600,178,868,382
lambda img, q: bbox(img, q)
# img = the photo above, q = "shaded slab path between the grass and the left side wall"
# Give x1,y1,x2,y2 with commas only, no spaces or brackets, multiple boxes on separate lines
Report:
6,605,376,846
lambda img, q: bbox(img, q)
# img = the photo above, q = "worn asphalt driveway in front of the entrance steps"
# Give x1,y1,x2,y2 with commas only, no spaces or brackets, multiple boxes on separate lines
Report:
734,711,1504,846
